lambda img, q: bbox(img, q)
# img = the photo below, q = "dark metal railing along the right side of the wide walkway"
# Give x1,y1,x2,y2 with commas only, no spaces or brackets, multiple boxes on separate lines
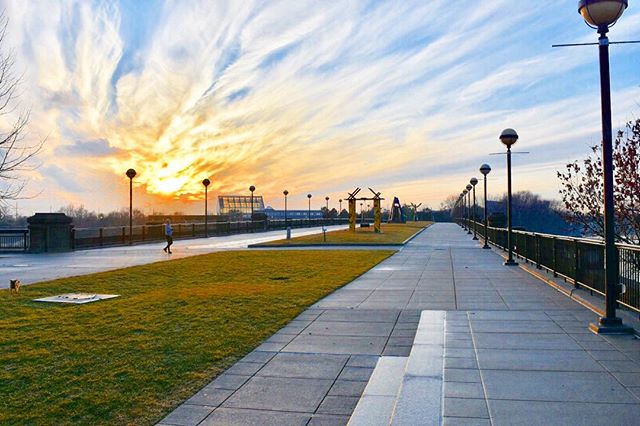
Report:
459,220,640,312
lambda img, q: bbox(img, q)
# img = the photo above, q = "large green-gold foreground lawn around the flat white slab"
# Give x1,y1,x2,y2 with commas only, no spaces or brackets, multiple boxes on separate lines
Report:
0,251,392,425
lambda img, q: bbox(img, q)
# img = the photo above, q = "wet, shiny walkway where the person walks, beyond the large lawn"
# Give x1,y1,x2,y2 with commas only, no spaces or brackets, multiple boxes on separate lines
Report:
0,225,346,289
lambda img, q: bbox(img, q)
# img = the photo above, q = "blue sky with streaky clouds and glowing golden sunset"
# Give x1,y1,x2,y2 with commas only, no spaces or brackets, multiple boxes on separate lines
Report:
0,0,640,214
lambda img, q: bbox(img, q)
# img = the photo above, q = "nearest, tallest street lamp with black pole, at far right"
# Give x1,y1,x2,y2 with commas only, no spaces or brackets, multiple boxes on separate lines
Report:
578,0,632,334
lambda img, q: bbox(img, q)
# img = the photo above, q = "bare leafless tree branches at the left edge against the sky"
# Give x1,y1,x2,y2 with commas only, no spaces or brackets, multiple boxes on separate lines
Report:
0,12,44,209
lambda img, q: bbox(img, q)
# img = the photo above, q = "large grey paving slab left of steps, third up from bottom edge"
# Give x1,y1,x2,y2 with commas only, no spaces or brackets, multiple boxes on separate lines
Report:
257,353,349,380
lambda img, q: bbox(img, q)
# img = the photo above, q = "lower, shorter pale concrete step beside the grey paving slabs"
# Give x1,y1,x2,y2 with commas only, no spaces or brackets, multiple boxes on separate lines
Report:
349,356,408,426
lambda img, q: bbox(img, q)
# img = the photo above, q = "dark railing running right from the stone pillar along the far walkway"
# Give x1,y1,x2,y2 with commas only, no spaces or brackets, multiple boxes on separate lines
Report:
71,218,348,249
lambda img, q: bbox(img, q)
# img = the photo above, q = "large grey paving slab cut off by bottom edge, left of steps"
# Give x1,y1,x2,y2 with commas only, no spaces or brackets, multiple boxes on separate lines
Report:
200,408,311,426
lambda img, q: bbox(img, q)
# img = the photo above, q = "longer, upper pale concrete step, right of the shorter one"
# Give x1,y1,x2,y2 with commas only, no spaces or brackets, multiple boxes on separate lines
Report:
391,311,446,426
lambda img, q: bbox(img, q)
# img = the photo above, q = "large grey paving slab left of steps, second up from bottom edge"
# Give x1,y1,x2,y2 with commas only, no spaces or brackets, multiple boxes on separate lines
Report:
223,377,333,413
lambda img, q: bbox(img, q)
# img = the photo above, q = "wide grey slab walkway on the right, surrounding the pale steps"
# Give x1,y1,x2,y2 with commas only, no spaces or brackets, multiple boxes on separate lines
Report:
162,224,640,425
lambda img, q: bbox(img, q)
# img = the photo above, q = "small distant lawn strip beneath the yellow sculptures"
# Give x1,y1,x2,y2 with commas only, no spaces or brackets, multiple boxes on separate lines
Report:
257,222,432,247
